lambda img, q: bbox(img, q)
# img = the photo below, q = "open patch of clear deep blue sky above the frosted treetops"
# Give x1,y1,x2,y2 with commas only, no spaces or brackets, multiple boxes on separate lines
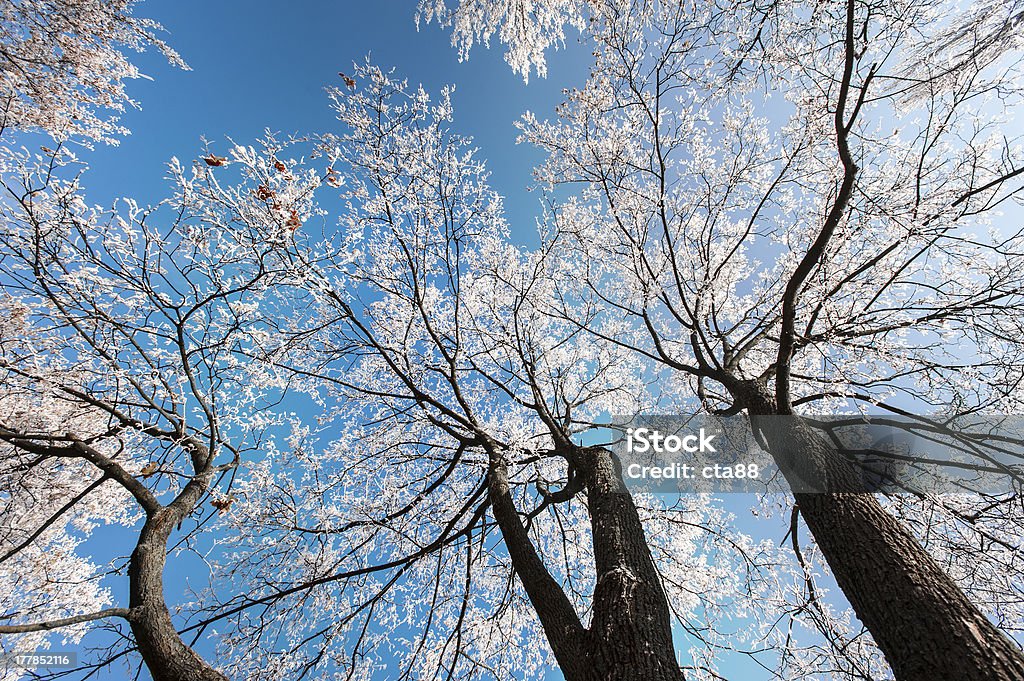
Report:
88,0,589,242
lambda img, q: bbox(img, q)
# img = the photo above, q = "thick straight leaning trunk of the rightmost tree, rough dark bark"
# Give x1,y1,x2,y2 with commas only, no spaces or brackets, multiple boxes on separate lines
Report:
736,378,1024,681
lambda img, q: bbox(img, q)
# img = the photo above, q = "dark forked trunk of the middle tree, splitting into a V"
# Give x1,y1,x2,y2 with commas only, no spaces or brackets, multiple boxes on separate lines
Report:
488,450,683,681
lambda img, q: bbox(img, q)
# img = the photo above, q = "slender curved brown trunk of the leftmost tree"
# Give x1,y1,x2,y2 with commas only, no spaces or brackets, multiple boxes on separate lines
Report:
128,473,227,681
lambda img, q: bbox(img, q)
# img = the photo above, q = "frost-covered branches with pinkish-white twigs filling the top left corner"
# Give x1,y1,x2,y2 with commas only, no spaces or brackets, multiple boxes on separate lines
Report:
0,0,187,143
